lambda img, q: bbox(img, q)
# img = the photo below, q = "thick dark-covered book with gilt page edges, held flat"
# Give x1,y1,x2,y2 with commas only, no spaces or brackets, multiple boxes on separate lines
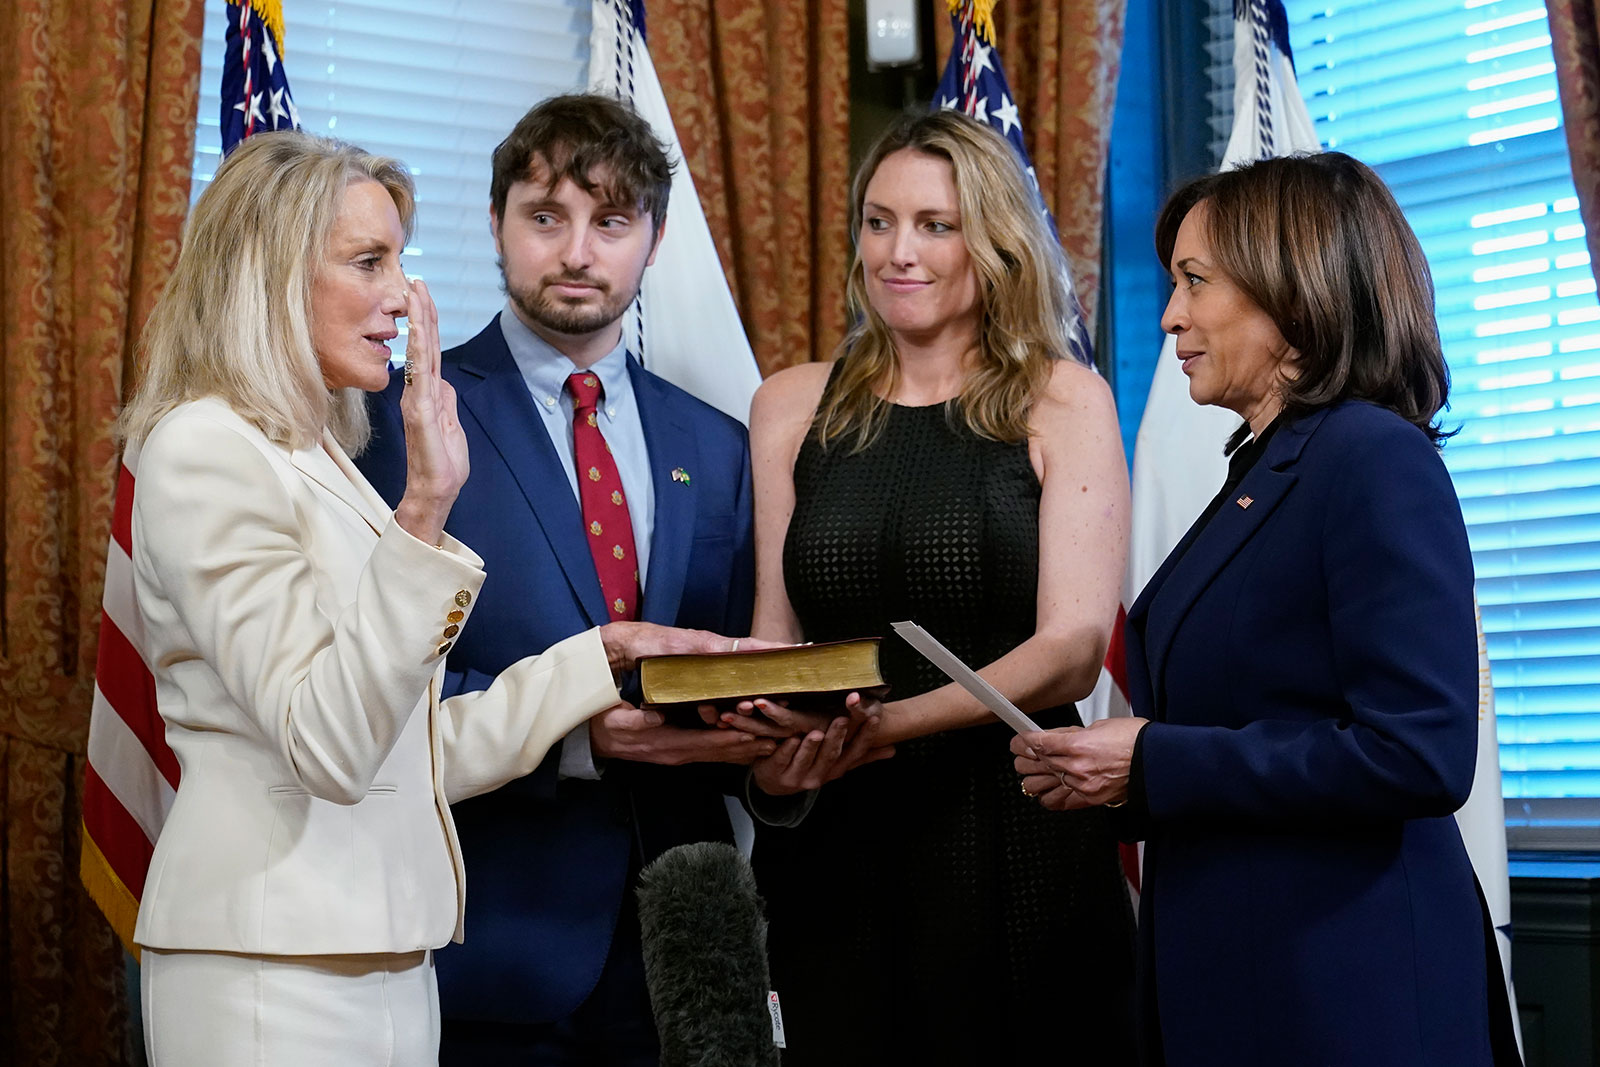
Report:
638,637,883,705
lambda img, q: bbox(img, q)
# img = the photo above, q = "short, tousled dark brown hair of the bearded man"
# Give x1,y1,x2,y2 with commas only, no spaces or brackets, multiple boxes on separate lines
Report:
490,93,672,230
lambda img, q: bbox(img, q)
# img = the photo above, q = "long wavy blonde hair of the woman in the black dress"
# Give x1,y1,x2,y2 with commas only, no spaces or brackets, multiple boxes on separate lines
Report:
814,110,1077,451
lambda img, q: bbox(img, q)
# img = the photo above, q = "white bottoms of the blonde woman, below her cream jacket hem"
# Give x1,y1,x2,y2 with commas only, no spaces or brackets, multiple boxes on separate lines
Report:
139,949,438,1067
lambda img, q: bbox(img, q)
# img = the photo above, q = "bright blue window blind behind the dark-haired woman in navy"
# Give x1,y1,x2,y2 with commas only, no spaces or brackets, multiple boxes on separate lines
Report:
1260,0,1600,846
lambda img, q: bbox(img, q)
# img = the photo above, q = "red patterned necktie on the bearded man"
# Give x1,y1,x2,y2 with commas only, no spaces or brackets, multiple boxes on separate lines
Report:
566,371,638,621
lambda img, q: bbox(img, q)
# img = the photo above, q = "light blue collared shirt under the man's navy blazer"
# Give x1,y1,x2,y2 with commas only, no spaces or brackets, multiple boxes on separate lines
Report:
501,301,656,779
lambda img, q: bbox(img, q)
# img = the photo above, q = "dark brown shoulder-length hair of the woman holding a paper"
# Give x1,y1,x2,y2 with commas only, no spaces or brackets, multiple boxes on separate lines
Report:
1155,152,1450,443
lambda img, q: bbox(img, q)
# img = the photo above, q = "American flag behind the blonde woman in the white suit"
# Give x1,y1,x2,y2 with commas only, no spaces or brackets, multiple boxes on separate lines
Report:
78,0,299,955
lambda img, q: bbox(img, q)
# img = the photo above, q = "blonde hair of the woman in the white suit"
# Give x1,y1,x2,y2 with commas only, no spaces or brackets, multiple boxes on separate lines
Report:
118,131,416,454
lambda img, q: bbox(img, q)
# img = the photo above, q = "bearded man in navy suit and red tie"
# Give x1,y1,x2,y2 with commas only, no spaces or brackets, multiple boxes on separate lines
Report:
360,94,773,1065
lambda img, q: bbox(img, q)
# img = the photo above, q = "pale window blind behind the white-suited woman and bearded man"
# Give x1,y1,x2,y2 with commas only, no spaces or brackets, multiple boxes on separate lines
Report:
192,0,590,343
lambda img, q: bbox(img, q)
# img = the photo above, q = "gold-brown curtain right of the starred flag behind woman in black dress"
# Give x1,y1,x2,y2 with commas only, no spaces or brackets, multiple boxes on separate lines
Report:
931,0,1128,336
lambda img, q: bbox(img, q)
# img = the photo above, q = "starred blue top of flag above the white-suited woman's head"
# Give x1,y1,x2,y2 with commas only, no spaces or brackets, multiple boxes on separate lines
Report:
222,0,299,155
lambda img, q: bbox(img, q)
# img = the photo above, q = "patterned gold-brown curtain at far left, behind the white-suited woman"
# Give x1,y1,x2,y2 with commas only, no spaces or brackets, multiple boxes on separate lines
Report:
0,0,205,1065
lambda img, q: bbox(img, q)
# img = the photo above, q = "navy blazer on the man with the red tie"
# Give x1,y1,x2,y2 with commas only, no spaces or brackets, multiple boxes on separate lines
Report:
357,317,755,1022
